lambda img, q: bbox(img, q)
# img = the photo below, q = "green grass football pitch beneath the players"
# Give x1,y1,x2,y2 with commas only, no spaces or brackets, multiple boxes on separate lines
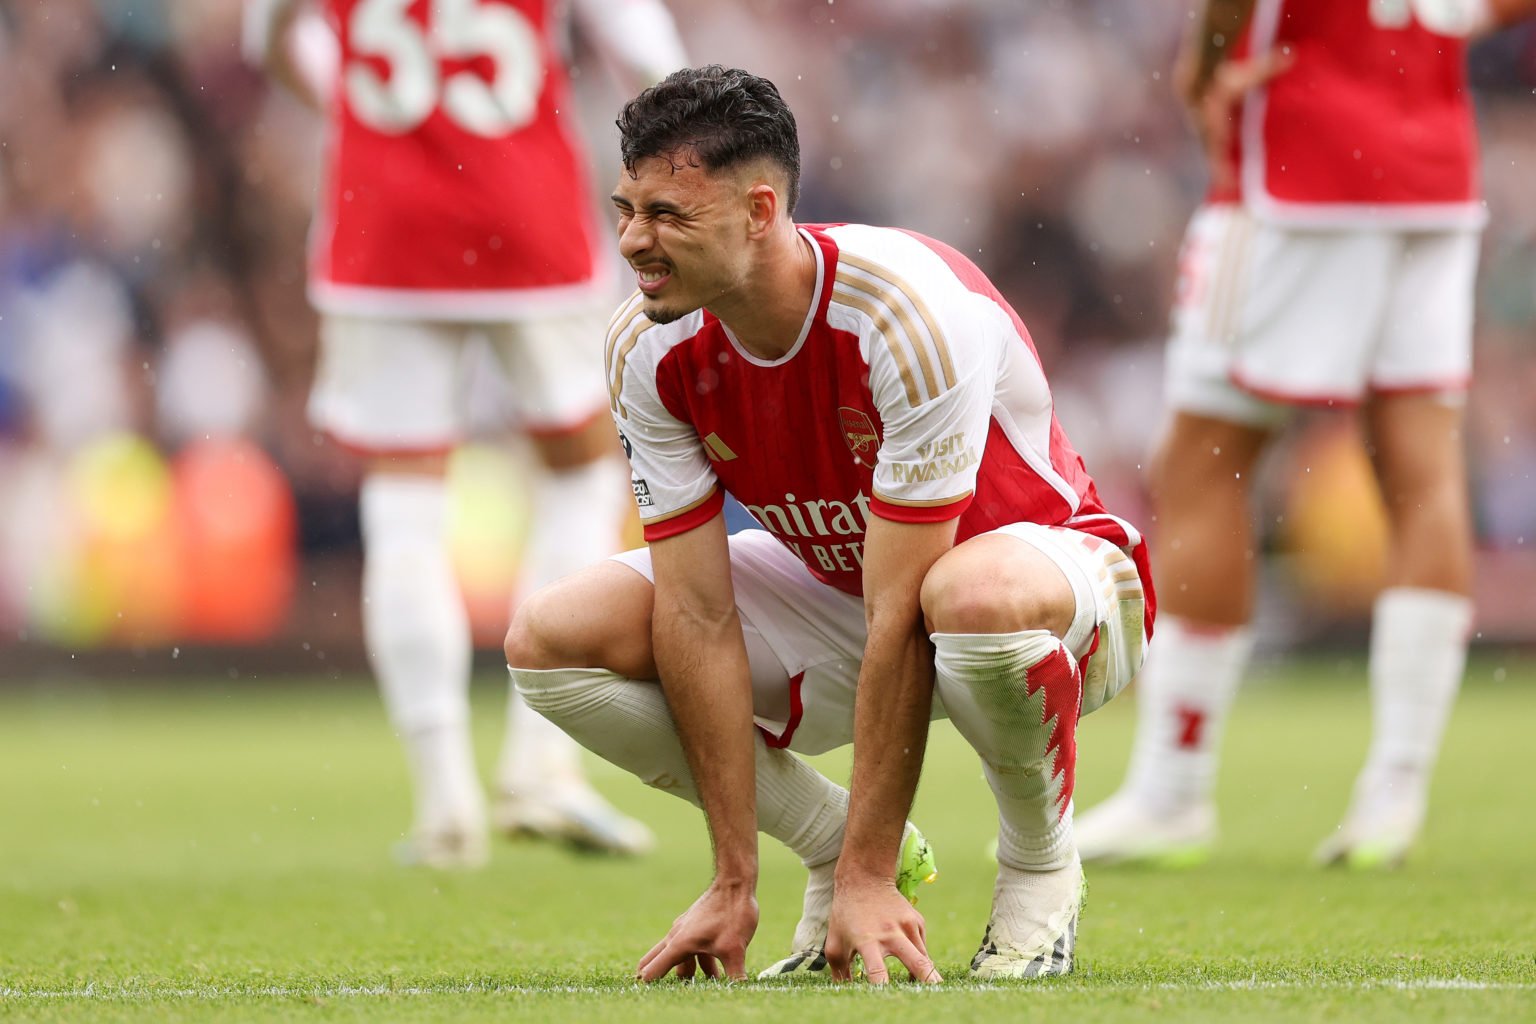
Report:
0,656,1536,1024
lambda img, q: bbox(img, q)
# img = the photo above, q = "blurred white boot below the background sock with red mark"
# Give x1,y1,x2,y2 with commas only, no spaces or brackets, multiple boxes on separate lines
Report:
1072,789,1217,867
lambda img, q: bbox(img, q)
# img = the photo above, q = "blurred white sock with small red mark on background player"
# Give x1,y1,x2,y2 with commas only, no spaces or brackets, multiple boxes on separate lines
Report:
1123,616,1253,814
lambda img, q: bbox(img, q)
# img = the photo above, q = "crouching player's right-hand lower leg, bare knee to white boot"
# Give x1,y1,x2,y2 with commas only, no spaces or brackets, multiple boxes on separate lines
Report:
923,534,1087,978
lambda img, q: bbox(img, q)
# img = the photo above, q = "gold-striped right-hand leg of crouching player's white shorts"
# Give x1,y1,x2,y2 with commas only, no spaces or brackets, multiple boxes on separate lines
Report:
977,522,1147,714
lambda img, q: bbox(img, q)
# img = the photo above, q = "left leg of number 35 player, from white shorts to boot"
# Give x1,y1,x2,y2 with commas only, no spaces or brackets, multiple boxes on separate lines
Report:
309,316,485,867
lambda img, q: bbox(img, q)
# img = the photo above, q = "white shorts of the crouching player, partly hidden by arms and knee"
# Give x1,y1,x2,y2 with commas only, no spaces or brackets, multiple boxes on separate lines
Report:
613,522,1144,754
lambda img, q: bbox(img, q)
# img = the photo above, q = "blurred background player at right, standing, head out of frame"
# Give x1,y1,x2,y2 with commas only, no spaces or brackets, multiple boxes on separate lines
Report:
1078,0,1536,866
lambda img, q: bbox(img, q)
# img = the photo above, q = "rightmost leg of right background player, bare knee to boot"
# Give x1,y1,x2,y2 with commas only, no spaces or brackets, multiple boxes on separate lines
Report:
1318,395,1471,867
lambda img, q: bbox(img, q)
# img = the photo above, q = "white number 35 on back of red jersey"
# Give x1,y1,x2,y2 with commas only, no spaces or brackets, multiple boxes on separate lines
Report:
344,0,544,138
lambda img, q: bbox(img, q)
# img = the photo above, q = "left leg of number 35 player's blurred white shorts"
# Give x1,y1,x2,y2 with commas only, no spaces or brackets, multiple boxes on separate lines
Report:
309,315,473,453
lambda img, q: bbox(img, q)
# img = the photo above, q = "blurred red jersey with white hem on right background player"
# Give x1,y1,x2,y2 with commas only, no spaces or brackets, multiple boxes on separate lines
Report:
1228,0,1484,229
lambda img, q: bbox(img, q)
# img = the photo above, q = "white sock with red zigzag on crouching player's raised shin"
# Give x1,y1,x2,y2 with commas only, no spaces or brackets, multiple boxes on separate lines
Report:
932,629,1083,870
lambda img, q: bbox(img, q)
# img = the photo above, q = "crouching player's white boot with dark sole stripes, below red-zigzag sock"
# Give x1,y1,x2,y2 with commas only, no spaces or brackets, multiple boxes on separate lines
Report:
971,857,1087,981
